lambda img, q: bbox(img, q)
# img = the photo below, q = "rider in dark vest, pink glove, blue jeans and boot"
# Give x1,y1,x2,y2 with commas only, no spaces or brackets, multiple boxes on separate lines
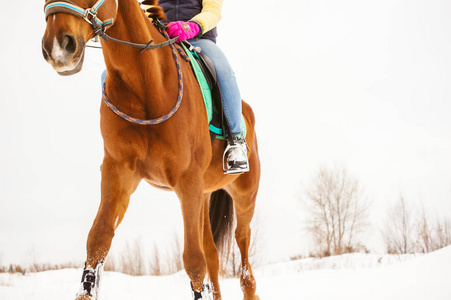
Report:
148,0,249,174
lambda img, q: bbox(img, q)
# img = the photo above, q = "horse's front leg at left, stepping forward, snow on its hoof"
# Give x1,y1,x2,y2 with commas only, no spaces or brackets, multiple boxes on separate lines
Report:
76,157,140,300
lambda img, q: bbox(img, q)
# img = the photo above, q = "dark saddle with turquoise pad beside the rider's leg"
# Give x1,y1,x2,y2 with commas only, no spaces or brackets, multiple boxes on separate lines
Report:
181,41,246,144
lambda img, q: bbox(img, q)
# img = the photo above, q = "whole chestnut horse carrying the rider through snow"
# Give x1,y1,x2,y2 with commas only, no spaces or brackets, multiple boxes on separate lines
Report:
42,0,260,300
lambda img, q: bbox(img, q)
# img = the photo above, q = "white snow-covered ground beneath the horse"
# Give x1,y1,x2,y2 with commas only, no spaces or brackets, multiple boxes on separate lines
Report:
0,246,451,300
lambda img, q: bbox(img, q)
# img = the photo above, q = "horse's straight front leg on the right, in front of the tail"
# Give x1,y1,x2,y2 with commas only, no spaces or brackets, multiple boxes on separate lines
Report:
174,174,206,299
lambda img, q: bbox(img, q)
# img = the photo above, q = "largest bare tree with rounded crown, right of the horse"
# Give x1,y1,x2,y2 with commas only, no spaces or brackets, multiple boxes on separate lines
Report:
303,168,369,256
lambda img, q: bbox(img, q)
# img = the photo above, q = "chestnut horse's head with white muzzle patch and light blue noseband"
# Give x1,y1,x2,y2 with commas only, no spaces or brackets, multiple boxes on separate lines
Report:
42,0,118,75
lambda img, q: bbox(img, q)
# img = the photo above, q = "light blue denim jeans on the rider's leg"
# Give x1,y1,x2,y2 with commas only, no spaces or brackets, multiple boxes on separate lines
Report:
188,39,242,134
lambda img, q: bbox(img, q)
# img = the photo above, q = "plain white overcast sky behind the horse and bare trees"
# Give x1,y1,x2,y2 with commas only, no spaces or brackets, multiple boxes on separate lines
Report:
0,0,451,264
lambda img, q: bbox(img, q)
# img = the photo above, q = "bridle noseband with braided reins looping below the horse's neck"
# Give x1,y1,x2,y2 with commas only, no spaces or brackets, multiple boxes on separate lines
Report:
44,0,187,125
